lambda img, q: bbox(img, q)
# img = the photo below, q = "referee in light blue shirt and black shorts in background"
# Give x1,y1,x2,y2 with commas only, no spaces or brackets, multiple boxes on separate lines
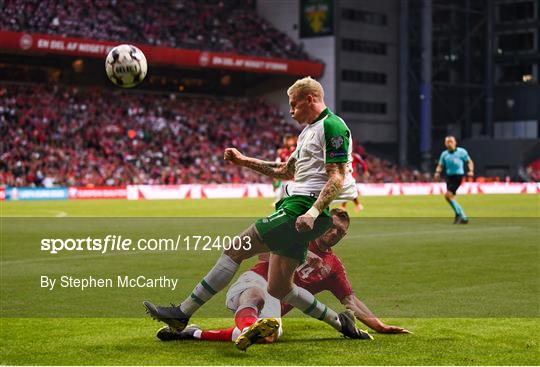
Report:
435,136,474,224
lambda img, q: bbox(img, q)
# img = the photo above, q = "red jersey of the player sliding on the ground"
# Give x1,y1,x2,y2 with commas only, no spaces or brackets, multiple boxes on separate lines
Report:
250,241,354,315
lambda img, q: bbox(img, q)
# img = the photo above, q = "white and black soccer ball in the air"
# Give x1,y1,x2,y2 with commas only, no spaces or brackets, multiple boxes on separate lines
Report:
105,45,148,88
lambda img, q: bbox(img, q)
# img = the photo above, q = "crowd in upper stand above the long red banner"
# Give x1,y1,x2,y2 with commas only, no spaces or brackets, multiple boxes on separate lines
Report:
0,0,309,60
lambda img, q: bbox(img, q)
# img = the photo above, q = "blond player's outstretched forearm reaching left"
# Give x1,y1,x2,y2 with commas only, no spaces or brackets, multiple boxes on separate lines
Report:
223,148,296,180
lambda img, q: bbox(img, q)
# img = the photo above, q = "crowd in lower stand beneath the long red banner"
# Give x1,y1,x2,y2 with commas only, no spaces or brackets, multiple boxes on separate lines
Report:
0,85,431,186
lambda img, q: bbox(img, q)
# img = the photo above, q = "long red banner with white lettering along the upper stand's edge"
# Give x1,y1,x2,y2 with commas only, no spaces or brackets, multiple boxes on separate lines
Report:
0,31,324,77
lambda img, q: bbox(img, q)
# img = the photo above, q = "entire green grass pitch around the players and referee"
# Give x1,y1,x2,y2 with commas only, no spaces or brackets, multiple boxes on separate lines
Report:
0,195,540,365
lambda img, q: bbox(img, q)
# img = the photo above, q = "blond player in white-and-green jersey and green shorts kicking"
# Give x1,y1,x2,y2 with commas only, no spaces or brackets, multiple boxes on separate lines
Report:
144,77,370,346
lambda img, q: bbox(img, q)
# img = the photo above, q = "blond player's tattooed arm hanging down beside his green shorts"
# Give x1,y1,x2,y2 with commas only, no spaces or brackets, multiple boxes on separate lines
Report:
296,163,347,232
